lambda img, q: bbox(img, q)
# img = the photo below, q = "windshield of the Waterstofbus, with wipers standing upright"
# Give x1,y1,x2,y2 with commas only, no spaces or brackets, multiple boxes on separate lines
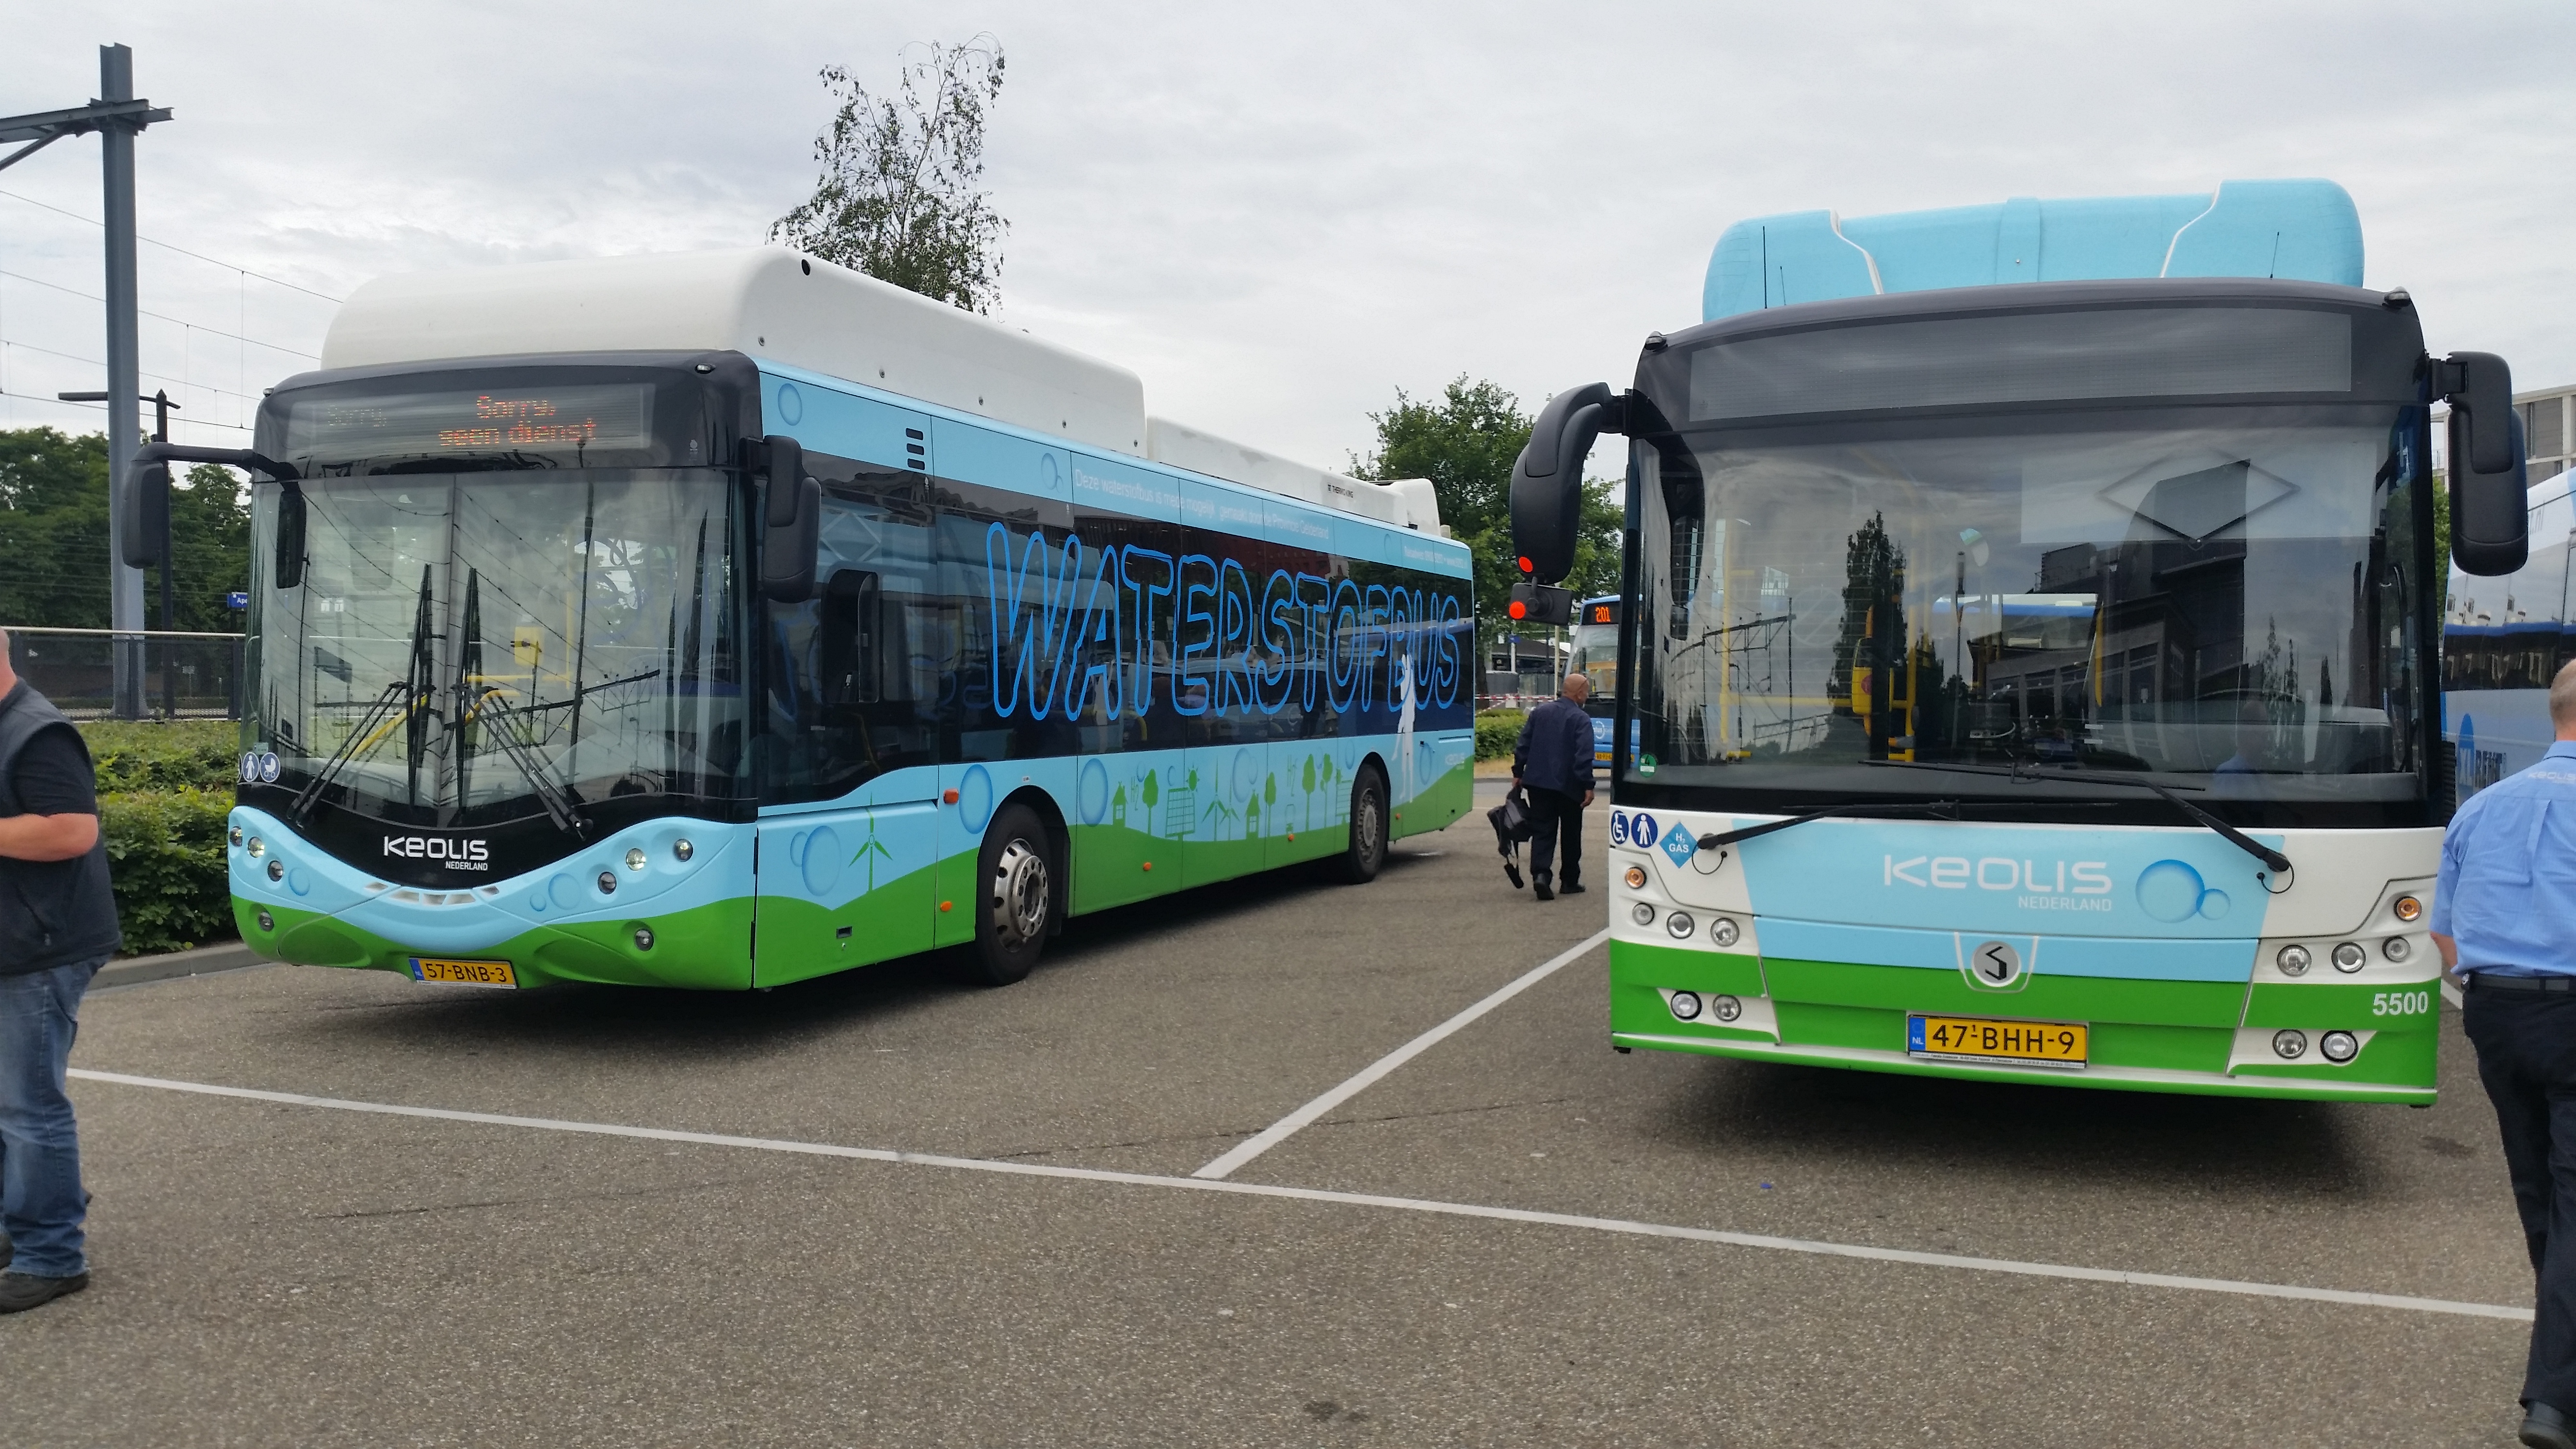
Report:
250,469,744,825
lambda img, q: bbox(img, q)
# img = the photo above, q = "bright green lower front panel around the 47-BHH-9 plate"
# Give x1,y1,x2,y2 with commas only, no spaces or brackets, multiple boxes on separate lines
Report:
1610,941,2437,1104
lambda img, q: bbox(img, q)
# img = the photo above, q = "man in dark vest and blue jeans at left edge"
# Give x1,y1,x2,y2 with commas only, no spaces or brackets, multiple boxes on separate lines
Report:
0,632,118,1312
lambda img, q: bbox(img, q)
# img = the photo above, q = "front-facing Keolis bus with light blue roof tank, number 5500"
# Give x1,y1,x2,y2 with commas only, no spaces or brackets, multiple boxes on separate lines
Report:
1512,180,2525,1104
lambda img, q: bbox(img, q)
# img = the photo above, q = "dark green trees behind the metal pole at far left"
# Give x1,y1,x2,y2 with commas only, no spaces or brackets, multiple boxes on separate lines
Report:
0,428,250,632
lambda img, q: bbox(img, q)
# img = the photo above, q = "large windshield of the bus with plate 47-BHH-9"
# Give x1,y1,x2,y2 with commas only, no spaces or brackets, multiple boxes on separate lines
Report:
1628,405,2429,822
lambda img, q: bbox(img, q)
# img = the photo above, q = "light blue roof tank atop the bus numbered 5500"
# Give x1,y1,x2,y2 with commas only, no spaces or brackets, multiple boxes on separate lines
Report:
1700,180,2362,322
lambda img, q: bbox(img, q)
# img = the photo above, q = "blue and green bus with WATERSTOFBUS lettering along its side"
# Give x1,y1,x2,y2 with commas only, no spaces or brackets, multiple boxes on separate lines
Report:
129,247,1473,987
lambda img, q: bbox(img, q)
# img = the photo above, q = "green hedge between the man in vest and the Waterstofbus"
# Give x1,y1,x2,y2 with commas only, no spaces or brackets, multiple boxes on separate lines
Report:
80,719,242,957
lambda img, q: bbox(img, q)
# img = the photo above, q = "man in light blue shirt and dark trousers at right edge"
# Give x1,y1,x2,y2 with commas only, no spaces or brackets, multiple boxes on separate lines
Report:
2432,662,2576,1449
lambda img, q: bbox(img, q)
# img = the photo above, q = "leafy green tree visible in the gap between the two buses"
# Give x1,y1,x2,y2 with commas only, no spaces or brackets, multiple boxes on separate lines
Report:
1350,374,1623,670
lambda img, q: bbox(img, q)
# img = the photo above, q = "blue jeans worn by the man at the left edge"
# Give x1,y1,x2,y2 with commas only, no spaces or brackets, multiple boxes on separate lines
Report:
0,957,106,1279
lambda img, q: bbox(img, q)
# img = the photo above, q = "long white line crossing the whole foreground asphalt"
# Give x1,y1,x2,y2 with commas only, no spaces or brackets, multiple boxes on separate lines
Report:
69,1067,2532,1322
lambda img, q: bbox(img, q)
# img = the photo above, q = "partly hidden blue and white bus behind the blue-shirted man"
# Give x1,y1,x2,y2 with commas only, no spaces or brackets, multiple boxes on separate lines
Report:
2442,387,2576,799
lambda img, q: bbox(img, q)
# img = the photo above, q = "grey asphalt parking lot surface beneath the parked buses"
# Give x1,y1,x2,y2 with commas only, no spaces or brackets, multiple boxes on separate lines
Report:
0,794,2529,1447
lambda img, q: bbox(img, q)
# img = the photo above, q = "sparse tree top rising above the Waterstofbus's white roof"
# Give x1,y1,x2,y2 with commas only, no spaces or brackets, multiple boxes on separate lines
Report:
770,36,1010,312
